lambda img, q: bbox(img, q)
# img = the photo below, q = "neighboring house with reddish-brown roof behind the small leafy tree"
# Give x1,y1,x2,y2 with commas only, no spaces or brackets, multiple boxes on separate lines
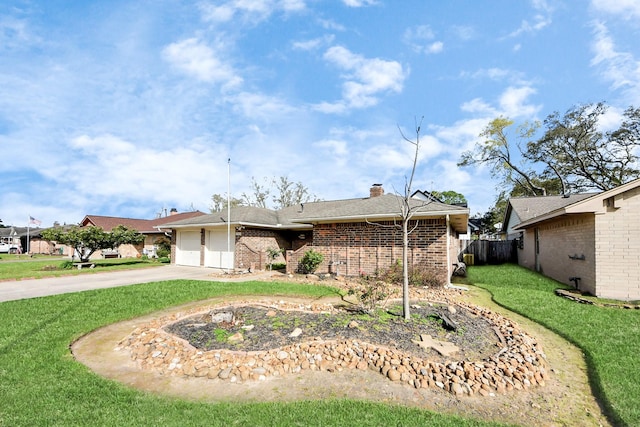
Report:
80,209,204,259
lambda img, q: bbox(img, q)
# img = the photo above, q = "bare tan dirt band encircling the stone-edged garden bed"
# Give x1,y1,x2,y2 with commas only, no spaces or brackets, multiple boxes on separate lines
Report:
72,291,607,426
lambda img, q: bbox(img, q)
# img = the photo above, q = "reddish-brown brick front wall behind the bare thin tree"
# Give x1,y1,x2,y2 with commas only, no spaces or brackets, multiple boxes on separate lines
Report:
287,218,448,280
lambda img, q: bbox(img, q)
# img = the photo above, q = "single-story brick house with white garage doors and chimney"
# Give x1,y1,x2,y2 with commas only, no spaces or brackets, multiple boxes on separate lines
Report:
164,185,469,282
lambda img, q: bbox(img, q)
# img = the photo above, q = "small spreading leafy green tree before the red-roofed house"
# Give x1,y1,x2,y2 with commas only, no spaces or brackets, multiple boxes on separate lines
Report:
42,225,144,262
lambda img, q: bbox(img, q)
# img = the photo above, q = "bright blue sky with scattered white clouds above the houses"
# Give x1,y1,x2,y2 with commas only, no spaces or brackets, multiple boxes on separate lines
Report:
0,0,640,227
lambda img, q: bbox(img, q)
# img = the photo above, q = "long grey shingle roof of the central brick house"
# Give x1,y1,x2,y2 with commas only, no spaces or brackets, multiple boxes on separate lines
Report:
160,194,469,232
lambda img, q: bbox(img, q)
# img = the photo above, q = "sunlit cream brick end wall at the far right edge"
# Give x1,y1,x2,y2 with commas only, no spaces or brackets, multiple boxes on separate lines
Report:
595,189,640,300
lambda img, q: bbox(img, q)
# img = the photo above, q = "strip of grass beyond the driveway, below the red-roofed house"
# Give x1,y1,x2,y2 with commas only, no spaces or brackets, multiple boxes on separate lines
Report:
0,255,163,280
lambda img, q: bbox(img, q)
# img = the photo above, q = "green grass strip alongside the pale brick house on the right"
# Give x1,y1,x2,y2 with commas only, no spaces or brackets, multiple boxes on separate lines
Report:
467,265,640,426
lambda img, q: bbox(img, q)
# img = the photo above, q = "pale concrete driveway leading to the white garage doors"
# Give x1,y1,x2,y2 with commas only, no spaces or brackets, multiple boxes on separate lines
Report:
0,265,231,302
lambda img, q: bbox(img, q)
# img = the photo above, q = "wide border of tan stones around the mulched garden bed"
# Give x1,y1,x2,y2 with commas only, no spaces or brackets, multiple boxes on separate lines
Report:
115,300,549,396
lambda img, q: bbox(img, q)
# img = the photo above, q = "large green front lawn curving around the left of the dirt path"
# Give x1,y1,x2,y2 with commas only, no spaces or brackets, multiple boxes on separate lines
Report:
0,280,504,426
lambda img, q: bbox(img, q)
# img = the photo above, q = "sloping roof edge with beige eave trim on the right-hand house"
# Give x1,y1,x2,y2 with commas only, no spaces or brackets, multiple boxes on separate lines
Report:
514,179,640,229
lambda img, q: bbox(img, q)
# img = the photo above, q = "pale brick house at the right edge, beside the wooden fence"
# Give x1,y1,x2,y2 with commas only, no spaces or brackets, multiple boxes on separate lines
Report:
505,180,640,300
